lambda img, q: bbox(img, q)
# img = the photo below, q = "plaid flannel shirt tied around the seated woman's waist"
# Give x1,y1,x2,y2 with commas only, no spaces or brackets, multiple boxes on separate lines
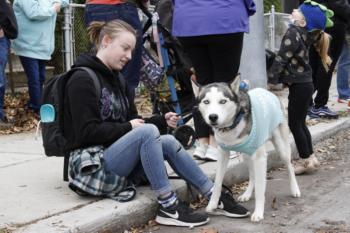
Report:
69,146,136,202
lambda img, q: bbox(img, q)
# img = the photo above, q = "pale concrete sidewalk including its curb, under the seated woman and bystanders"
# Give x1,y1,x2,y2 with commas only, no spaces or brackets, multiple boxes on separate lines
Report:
0,79,350,233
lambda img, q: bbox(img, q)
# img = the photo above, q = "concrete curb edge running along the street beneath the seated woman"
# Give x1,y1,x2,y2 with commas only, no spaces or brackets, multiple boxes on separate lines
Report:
13,118,350,233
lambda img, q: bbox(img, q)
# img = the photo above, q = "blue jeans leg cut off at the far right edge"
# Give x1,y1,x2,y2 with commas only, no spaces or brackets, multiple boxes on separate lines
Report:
337,43,350,99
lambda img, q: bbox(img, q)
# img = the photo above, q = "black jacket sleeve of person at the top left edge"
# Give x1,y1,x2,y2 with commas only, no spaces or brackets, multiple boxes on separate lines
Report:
0,0,18,39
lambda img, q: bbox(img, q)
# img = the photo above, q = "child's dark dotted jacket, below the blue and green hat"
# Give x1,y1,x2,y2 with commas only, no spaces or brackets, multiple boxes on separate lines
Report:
268,25,316,84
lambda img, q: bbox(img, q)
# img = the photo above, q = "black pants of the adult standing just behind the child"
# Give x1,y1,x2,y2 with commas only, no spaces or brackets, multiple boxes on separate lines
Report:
310,24,345,108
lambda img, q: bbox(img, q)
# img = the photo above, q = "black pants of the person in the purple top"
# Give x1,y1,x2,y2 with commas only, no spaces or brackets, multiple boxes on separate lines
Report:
179,33,243,138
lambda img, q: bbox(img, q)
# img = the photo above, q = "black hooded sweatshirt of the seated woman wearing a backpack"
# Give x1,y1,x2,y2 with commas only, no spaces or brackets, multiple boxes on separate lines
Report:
63,55,167,151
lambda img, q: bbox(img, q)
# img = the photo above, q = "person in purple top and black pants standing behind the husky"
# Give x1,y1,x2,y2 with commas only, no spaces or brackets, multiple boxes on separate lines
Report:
172,0,256,161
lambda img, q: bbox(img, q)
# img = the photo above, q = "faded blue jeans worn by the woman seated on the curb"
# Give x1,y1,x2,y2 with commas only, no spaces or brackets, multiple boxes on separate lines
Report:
103,124,213,196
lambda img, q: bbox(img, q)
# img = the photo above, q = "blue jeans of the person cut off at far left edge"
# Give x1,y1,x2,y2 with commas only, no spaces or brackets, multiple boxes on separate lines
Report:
0,36,10,120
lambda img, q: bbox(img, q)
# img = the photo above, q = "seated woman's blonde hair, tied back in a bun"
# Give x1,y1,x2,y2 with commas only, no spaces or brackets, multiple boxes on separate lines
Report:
87,19,137,49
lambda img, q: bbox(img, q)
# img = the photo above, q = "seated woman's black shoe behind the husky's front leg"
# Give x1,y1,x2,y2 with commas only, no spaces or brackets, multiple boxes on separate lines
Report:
213,190,250,218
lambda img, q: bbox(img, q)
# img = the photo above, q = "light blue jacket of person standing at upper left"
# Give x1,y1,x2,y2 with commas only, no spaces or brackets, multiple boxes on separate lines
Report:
12,0,69,60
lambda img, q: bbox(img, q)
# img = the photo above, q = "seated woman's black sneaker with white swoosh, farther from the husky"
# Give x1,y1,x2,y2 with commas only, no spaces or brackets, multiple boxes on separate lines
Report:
156,200,209,227
